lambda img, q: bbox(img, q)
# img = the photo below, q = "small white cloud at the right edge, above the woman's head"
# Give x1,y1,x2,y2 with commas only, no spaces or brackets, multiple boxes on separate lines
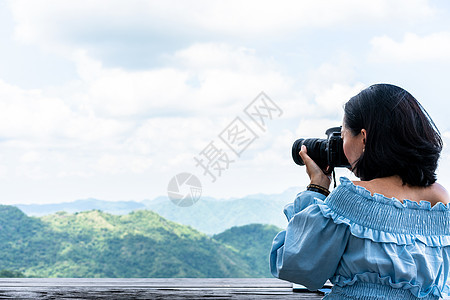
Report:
370,32,450,62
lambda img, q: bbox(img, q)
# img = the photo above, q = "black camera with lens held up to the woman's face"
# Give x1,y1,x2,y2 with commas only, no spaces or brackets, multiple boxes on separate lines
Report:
292,127,350,171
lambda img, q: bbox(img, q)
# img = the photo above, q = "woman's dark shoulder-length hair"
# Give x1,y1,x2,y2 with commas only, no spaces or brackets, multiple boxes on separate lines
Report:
344,84,442,187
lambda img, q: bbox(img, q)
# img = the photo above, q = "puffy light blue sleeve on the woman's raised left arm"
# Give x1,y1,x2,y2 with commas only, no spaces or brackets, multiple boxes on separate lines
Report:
270,191,350,290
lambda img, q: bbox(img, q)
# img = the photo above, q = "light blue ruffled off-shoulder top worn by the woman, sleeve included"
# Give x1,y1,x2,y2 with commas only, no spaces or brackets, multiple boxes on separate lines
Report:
270,177,450,299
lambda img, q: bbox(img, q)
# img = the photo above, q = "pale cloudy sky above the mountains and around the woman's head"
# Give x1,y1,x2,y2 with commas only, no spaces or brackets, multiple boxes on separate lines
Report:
0,0,450,204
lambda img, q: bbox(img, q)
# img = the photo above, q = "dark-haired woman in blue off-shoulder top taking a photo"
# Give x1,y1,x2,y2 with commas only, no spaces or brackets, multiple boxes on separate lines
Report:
270,84,450,299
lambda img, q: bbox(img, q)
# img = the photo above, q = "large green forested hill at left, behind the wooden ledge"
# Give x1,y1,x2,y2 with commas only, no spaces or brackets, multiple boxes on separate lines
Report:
0,206,280,277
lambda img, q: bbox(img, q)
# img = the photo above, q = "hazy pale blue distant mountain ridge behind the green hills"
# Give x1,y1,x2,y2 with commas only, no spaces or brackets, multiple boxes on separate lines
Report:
15,188,299,235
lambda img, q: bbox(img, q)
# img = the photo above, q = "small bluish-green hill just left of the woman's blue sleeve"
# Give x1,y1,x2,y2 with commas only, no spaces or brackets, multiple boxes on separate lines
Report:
213,224,281,277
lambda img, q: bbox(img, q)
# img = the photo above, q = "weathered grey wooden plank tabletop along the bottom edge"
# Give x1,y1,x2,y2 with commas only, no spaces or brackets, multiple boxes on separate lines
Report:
0,278,323,300
